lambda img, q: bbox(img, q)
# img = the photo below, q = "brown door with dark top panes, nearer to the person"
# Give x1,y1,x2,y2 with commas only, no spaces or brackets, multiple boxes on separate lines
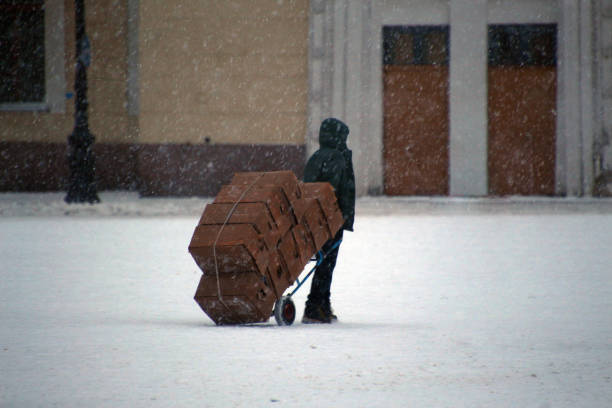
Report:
383,27,449,195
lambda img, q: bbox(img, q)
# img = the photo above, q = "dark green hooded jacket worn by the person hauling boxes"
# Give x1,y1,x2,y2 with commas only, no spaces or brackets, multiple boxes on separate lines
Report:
304,118,355,231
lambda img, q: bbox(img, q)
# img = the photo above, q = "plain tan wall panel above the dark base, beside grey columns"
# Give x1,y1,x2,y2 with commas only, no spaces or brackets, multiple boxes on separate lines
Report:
139,0,308,145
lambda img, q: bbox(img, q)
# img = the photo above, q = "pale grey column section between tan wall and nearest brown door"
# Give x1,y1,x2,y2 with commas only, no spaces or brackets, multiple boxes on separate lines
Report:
306,0,382,195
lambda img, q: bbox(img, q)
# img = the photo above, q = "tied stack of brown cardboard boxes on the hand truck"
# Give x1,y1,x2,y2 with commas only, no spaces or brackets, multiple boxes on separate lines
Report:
189,171,344,324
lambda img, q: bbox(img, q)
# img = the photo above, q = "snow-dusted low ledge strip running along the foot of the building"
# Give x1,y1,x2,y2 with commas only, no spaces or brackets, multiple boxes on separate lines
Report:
0,192,612,218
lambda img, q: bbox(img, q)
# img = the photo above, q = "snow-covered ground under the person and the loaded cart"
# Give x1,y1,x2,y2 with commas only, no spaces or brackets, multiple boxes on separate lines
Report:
0,193,612,408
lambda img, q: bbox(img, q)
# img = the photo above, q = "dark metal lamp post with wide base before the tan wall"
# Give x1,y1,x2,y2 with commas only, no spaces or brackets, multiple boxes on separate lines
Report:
64,0,100,204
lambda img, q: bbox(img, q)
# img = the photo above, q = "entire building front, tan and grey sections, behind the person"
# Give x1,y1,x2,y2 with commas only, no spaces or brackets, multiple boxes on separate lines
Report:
0,0,612,197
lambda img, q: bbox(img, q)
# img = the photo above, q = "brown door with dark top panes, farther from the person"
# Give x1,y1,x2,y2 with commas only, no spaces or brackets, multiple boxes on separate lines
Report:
487,25,557,196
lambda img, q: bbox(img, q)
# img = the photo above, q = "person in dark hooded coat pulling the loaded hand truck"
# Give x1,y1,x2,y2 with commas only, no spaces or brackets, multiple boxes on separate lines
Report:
302,118,355,323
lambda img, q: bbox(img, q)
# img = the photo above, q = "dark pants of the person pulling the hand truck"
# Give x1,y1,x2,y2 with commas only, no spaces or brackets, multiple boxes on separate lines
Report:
308,229,343,307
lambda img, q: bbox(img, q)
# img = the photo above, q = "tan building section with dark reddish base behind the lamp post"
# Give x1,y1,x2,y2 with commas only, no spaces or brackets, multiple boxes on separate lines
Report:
0,0,308,196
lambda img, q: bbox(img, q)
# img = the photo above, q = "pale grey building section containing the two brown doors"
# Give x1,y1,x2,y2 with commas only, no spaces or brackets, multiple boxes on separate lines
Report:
306,0,612,196
